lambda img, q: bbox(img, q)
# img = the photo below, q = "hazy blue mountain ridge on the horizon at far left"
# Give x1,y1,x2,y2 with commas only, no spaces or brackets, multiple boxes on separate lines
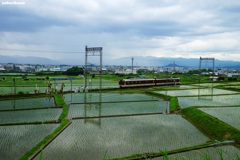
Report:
0,55,60,64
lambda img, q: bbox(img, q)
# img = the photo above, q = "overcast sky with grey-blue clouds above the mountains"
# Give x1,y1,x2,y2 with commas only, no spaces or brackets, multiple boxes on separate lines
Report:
0,0,240,64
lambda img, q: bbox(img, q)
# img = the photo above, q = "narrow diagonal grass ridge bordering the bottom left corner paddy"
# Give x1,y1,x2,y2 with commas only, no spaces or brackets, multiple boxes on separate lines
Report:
19,120,71,160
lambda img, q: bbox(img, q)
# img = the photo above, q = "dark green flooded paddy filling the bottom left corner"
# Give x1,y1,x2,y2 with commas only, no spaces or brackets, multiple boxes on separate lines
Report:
0,124,58,160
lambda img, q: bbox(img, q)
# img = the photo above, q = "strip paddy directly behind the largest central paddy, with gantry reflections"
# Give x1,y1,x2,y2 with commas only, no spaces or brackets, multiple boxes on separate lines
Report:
68,100,168,118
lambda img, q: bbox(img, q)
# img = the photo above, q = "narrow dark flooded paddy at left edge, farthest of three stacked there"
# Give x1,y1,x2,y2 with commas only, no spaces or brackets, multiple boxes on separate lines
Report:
0,97,55,110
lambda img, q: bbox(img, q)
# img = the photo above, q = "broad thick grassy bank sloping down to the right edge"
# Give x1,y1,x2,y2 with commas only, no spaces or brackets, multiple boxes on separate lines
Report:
181,107,240,143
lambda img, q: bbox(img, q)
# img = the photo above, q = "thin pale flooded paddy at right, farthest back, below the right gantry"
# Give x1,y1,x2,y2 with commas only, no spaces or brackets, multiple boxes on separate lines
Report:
156,88,239,97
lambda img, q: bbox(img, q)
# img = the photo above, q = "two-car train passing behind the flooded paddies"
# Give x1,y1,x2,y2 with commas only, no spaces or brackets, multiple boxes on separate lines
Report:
119,78,180,88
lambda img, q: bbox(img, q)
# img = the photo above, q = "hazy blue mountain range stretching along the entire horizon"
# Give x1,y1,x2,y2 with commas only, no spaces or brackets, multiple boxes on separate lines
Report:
0,55,240,69
